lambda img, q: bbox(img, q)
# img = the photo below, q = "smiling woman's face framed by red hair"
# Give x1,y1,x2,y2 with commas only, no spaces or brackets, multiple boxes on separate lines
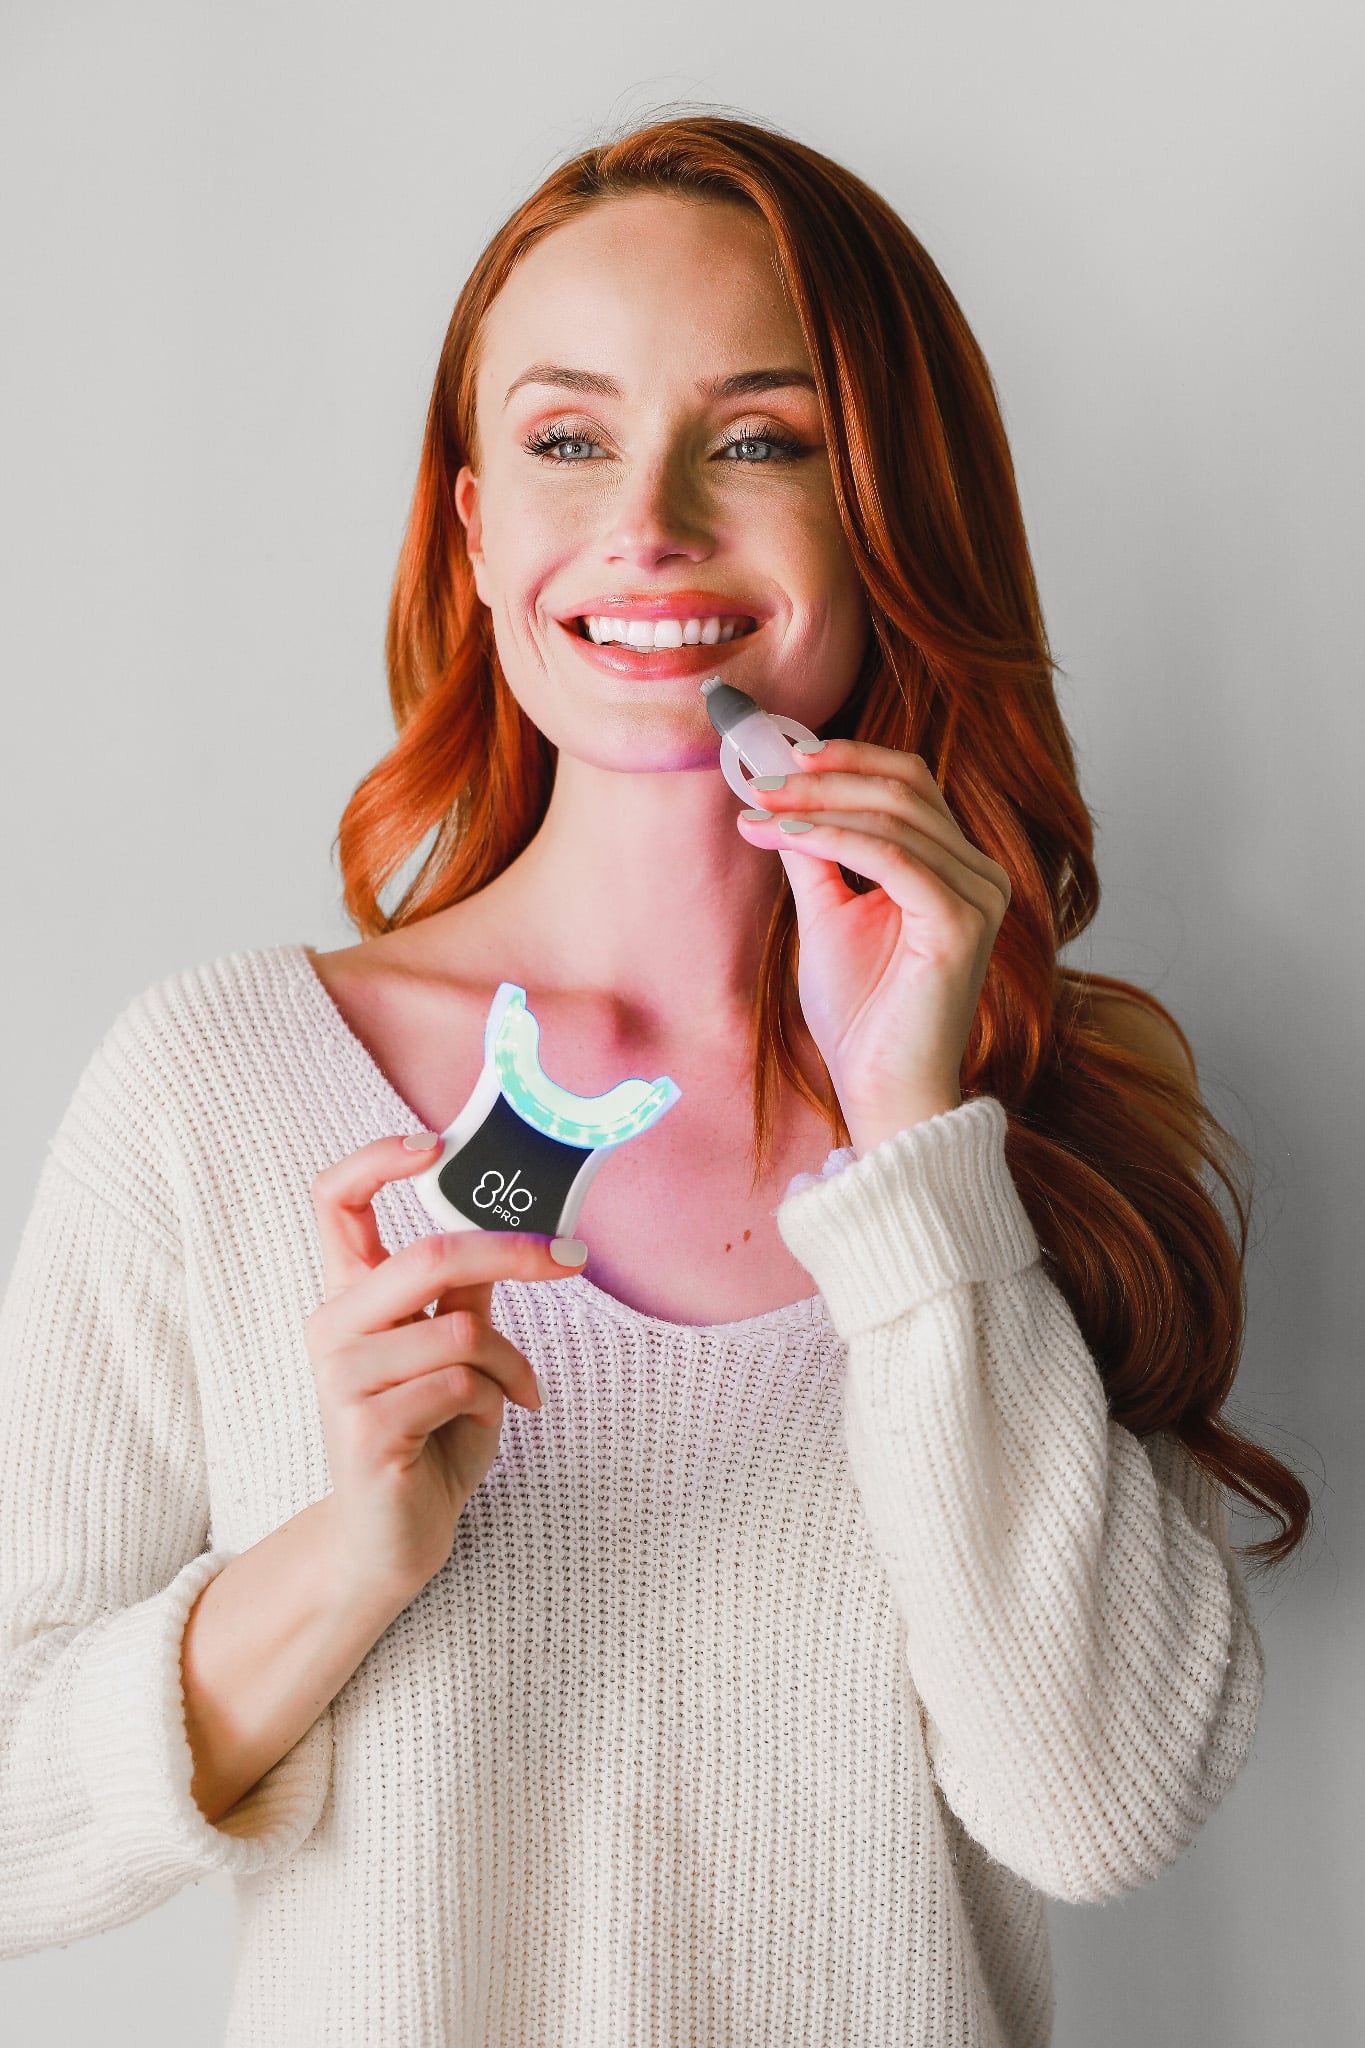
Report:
456,193,870,768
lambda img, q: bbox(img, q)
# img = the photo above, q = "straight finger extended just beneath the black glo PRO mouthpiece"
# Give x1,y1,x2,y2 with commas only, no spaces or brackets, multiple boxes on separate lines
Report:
311,1229,577,1333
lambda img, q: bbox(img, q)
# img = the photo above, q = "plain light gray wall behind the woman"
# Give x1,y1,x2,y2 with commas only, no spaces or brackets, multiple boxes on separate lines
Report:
0,0,1365,2048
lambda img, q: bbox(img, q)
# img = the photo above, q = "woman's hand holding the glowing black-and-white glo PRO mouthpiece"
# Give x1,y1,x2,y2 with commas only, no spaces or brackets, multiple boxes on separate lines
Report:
305,1137,581,1599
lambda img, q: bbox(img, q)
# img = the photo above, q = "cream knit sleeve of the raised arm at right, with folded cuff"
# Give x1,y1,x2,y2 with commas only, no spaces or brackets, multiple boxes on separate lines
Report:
778,1096,1265,1903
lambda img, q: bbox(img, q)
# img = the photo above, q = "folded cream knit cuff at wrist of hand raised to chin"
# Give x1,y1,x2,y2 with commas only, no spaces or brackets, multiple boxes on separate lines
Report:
776,1096,1040,1341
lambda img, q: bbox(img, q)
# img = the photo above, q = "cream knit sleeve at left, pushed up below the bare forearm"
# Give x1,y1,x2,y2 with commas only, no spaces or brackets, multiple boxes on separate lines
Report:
0,1015,332,1958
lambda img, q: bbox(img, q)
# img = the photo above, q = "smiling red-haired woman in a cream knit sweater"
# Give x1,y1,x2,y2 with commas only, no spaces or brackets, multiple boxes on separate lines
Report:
0,117,1308,2048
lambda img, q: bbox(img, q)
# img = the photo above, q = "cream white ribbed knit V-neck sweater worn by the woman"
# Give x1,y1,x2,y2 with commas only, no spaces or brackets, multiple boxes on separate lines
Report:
0,944,1265,2048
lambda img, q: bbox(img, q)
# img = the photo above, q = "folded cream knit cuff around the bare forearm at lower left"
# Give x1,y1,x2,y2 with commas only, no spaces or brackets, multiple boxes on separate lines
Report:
70,1550,332,1884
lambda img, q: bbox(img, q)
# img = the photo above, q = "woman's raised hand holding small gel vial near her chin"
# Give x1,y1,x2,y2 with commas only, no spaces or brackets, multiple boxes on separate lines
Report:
737,739,1011,1155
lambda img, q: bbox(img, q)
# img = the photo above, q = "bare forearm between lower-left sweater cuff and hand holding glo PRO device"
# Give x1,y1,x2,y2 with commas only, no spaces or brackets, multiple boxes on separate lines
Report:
180,1495,413,1821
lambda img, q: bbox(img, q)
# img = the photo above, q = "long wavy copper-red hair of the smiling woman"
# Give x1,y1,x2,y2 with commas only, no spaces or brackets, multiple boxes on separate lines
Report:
336,111,1312,1571
